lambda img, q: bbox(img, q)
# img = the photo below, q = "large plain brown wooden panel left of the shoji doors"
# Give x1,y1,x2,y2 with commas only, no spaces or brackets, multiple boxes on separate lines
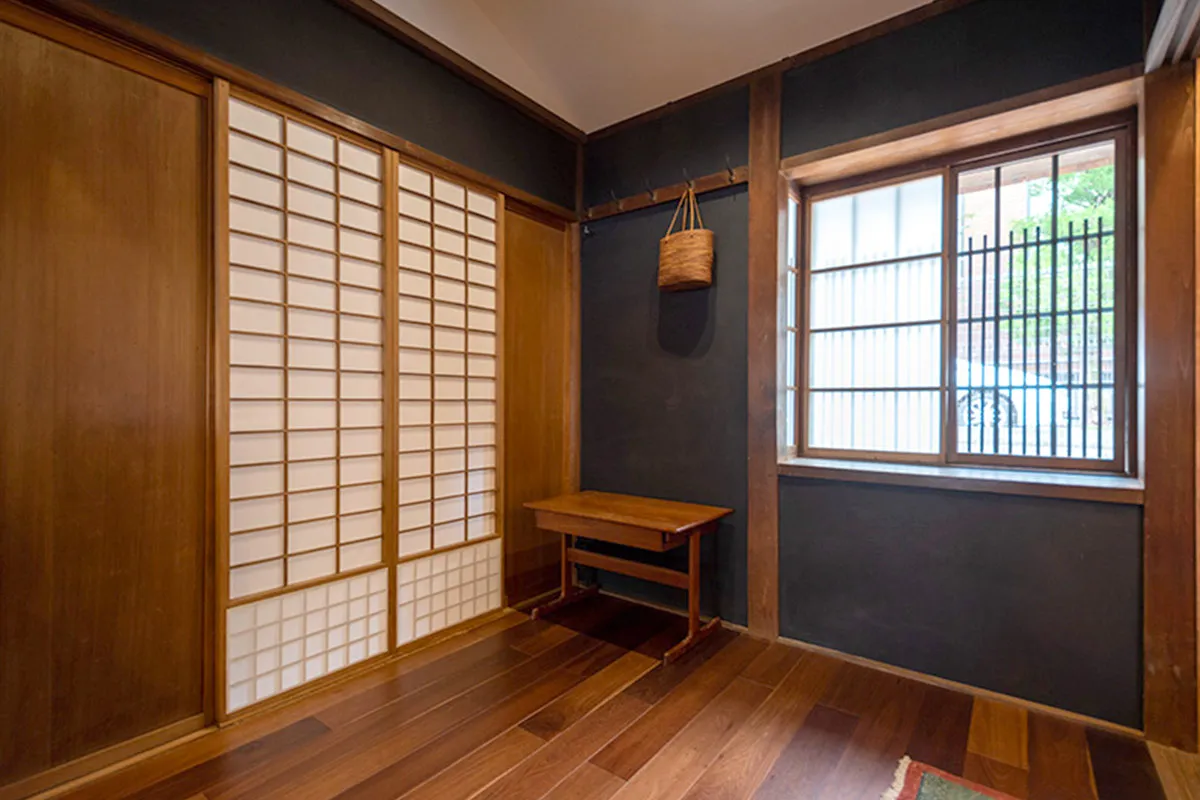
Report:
0,18,209,784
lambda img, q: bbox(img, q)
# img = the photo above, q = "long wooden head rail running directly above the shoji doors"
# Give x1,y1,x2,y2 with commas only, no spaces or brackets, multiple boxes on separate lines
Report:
17,0,577,222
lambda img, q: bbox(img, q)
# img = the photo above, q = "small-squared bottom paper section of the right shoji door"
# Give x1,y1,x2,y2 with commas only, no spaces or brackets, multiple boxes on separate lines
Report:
396,539,500,644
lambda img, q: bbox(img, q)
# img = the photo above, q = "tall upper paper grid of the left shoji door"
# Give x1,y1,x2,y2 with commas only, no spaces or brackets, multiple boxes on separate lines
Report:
229,98,384,599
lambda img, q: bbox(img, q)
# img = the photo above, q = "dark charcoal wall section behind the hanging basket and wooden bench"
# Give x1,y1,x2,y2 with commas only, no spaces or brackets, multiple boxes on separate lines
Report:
581,187,749,624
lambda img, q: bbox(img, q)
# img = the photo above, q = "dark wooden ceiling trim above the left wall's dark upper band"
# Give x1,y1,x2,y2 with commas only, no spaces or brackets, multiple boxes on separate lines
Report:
335,0,587,142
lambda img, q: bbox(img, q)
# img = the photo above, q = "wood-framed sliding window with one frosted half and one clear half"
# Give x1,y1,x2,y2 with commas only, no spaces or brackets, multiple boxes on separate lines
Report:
784,126,1132,471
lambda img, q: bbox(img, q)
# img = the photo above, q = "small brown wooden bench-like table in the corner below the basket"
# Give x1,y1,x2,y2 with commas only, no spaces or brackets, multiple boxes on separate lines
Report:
524,492,733,663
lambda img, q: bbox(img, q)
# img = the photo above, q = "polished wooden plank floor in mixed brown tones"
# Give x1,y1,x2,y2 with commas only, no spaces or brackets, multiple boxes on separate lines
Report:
46,596,1200,800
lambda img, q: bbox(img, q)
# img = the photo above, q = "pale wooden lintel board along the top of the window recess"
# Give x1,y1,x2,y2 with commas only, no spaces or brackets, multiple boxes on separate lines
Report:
782,65,1142,186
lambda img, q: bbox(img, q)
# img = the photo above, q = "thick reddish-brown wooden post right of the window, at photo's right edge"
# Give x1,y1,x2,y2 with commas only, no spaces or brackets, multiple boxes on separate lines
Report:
1142,64,1198,751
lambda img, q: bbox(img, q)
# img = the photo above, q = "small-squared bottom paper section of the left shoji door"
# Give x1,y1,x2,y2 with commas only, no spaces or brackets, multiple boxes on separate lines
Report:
226,570,388,711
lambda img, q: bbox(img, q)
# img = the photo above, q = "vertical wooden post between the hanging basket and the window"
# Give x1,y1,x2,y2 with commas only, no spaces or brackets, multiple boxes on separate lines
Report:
746,72,787,639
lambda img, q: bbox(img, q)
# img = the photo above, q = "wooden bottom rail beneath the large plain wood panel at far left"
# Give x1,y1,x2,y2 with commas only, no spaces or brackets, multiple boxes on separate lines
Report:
0,714,206,800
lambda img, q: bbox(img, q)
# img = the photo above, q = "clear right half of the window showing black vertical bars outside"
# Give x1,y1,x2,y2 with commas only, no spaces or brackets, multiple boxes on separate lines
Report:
952,140,1121,462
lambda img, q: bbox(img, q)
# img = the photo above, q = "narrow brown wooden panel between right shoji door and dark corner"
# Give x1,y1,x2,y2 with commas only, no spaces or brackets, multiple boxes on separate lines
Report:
503,203,578,606
